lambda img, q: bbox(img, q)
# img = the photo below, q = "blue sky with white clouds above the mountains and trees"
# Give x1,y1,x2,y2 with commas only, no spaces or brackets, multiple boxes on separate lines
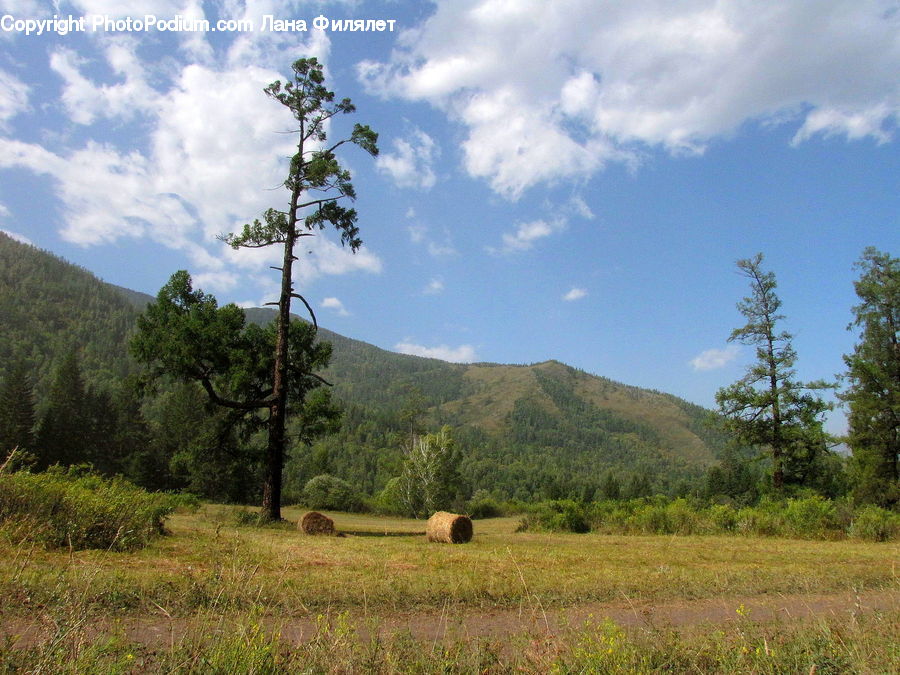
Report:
0,0,900,432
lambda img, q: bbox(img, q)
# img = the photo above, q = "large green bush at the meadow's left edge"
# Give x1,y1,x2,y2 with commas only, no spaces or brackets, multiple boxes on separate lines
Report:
0,467,178,551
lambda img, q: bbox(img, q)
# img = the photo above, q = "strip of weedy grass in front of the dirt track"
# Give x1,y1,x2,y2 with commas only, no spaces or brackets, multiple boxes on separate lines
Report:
0,611,900,674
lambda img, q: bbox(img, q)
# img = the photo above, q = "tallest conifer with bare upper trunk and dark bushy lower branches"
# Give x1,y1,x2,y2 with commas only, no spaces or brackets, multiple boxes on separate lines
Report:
132,58,378,520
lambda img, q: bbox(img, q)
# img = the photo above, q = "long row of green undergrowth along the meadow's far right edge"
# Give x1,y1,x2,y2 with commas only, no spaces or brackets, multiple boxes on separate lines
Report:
519,497,900,541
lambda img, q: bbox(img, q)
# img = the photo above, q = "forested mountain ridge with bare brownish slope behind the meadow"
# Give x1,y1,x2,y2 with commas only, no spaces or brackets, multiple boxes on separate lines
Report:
0,233,725,498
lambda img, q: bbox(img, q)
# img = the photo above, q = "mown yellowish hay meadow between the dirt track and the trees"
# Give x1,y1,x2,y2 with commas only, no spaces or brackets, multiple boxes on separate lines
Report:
0,506,900,616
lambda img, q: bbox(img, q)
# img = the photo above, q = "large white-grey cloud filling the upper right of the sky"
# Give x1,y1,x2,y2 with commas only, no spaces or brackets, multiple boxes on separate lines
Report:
358,0,900,199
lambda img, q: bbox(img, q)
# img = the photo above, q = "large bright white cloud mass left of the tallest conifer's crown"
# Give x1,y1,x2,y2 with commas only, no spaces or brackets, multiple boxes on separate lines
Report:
0,33,381,300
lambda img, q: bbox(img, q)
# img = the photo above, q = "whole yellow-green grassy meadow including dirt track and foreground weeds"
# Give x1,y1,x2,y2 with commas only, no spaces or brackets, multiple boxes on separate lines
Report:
0,505,900,673
